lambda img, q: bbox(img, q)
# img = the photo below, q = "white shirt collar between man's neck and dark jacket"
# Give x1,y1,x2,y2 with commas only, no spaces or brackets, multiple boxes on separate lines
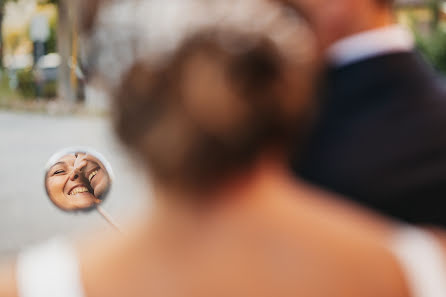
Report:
326,25,414,67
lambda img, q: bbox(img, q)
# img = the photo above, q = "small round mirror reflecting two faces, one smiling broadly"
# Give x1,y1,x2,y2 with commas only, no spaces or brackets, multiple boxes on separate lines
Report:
45,149,111,211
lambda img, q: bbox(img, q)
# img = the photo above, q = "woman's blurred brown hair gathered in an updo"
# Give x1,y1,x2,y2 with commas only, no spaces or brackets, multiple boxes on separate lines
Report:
114,30,311,190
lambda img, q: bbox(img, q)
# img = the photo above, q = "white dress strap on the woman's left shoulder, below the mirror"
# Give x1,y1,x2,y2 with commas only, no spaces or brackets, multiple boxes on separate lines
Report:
17,239,84,297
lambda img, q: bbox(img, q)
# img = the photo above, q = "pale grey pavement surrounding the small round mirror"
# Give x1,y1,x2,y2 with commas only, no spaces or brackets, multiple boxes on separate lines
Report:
0,111,150,256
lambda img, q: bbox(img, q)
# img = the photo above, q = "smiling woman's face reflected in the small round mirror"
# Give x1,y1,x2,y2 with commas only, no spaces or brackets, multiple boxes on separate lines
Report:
46,154,100,210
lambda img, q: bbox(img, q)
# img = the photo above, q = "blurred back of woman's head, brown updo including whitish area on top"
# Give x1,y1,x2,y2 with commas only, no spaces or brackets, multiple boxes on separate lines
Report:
76,0,315,190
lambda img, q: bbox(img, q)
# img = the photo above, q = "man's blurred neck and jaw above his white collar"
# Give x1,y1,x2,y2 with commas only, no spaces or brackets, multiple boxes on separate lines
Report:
274,0,395,51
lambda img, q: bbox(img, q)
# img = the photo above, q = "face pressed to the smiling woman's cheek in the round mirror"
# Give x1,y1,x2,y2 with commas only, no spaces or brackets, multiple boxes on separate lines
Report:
75,154,110,199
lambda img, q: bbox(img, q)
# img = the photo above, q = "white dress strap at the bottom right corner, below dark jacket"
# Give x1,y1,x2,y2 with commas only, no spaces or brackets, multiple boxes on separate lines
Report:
392,227,446,297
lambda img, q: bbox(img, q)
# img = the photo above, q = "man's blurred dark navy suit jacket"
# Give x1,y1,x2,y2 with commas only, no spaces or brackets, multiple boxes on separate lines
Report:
293,53,446,226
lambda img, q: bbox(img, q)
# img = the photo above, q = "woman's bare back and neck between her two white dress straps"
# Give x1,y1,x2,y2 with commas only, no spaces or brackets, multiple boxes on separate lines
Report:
79,160,410,297
